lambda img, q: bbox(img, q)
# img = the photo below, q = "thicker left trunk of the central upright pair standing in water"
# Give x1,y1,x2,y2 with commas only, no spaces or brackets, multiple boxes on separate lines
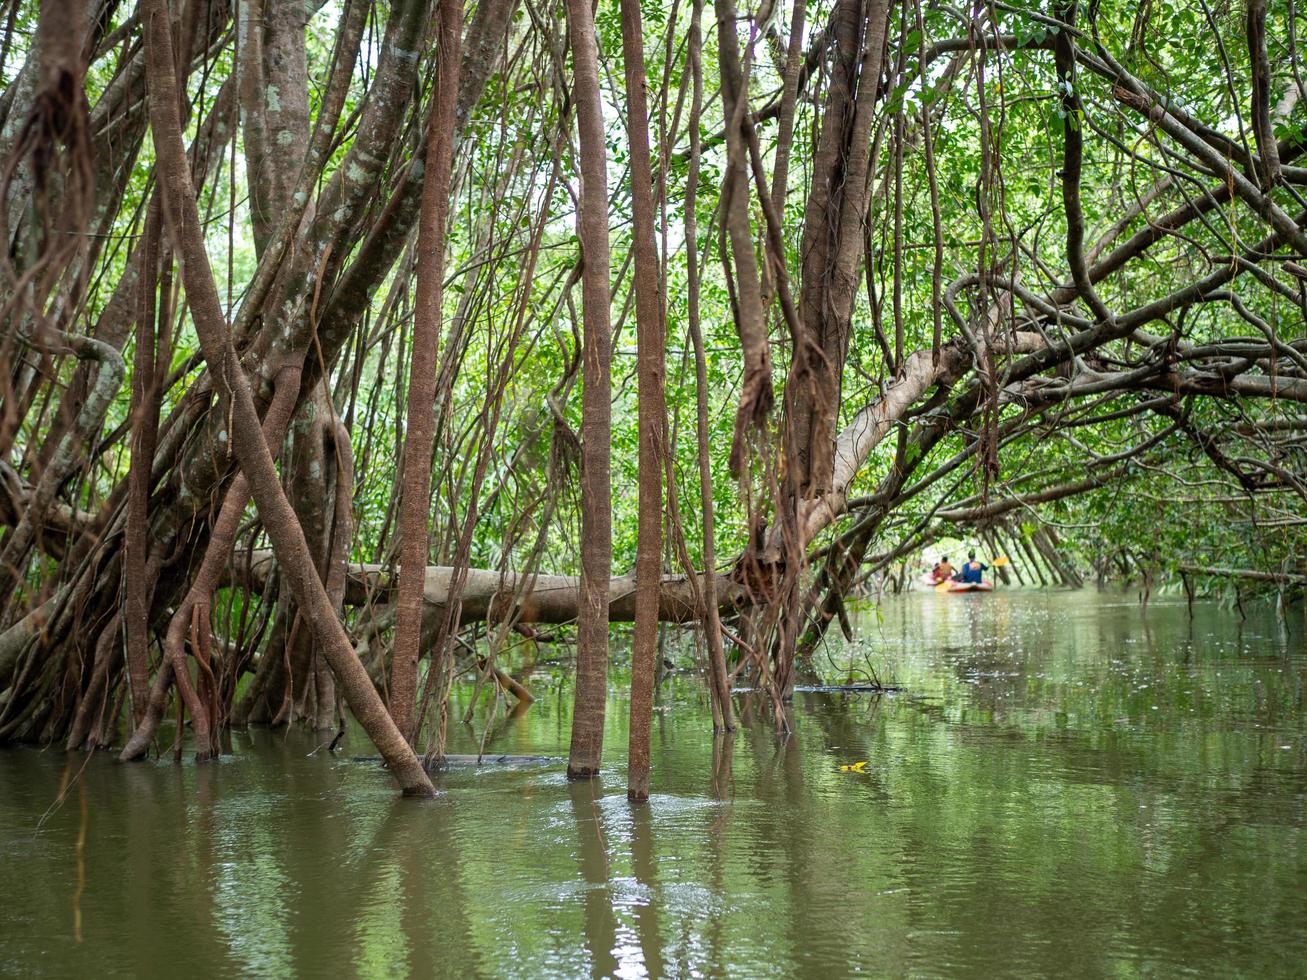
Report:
567,0,613,779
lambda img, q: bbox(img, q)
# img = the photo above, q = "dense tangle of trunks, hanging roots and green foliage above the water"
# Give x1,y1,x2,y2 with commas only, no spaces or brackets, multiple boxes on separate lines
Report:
0,0,1307,796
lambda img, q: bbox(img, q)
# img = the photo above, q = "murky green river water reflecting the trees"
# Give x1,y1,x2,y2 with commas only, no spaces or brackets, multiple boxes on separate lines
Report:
0,592,1307,977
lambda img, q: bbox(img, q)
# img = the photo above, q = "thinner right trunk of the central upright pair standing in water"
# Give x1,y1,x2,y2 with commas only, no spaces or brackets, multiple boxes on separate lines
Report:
621,0,667,801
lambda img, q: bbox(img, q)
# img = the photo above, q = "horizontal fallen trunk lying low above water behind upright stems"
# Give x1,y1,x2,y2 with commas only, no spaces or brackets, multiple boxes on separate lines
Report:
230,549,744,625
